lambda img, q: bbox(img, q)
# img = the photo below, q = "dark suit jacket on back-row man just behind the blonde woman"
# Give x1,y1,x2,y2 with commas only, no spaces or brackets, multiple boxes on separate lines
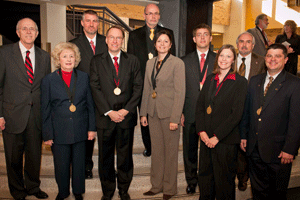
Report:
70,33,107,74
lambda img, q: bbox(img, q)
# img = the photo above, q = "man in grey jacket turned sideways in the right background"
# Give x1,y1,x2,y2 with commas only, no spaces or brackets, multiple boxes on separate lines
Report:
247,14,272,56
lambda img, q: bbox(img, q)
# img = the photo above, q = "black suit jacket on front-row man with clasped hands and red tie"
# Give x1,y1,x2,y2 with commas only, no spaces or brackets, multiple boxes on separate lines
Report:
90,52,143,129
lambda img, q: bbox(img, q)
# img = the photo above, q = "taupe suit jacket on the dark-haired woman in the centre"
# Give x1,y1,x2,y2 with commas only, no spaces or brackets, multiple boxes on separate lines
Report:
140,55,185,124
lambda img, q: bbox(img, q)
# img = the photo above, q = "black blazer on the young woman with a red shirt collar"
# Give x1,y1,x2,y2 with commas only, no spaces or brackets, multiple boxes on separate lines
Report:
196,74,248,144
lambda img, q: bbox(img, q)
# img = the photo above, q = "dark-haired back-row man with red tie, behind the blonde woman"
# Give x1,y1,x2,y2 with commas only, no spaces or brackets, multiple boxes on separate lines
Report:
70,10,107,179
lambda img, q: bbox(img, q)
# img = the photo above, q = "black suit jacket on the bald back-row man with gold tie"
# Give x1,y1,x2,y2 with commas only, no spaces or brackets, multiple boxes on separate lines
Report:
127,25,176,80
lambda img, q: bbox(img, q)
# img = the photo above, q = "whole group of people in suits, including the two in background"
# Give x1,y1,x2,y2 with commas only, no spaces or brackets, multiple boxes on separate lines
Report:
0,4,300,200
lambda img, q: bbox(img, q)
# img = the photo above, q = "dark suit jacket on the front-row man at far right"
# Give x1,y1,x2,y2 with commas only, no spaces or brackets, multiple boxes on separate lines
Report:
240,70,300,163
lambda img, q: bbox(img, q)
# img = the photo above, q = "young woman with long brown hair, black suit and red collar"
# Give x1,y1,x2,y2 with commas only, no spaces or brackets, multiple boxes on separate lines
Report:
196,45,247,200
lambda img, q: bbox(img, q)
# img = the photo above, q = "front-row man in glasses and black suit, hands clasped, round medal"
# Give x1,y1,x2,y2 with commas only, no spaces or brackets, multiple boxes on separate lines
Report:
90,26,143,200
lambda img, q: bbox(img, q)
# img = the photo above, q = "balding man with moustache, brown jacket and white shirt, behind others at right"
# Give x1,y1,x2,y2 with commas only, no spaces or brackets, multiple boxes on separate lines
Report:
236,32,265,191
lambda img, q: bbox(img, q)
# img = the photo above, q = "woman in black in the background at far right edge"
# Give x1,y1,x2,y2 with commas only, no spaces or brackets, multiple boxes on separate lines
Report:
275,20,300,75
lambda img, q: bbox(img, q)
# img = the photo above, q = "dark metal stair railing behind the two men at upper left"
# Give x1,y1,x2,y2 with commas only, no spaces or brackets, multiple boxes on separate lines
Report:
66,5,132,51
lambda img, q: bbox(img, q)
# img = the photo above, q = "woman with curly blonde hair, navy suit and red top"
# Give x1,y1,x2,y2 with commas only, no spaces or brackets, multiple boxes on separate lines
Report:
41,43,96,200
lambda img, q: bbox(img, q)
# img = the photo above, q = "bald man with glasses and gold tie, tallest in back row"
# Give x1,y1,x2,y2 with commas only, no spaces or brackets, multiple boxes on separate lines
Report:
127,4,176,157
